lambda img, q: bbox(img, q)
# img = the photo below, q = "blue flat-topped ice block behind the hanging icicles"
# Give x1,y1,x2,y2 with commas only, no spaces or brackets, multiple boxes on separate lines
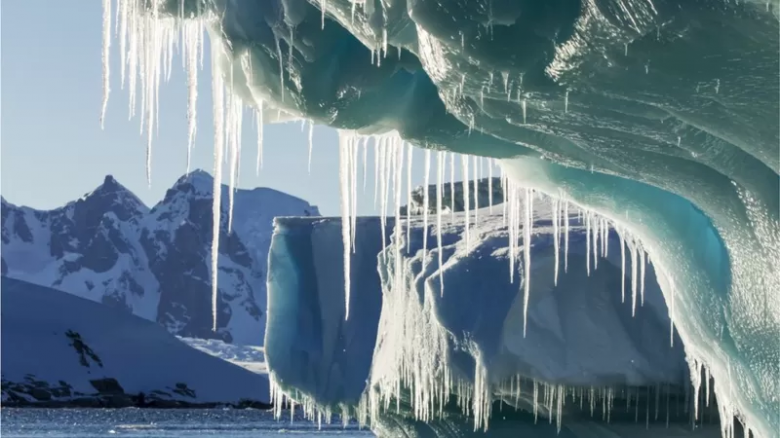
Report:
265,210,736,437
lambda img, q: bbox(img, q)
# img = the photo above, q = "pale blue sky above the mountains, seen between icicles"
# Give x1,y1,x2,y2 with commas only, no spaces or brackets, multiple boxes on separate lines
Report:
0,0,449,215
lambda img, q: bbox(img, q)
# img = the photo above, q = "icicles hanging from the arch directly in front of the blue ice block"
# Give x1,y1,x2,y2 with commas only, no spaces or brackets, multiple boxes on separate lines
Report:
339,131,673,340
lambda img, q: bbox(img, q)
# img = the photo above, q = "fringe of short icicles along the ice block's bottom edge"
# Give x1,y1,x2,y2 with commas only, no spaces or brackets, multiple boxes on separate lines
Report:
269,367,724,437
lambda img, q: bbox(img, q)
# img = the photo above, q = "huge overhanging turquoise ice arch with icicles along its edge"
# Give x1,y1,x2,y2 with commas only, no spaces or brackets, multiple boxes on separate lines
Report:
103,0,780,437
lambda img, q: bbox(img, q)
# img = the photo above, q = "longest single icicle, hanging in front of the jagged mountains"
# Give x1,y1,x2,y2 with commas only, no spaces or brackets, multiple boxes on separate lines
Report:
211,68,225,331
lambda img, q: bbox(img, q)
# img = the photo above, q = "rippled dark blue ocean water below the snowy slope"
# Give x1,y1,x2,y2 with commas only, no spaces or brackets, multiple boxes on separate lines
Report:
0,408,374,438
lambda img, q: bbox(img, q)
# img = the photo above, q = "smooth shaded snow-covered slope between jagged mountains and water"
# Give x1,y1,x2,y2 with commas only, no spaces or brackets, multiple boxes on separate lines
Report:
1,277,268,403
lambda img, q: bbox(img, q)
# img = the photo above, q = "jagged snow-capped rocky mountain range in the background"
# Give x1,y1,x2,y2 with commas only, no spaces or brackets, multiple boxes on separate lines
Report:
2,170,319,345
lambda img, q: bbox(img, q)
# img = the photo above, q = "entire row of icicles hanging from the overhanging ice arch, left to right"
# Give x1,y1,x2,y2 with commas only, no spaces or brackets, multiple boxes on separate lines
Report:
101,0,673,336
